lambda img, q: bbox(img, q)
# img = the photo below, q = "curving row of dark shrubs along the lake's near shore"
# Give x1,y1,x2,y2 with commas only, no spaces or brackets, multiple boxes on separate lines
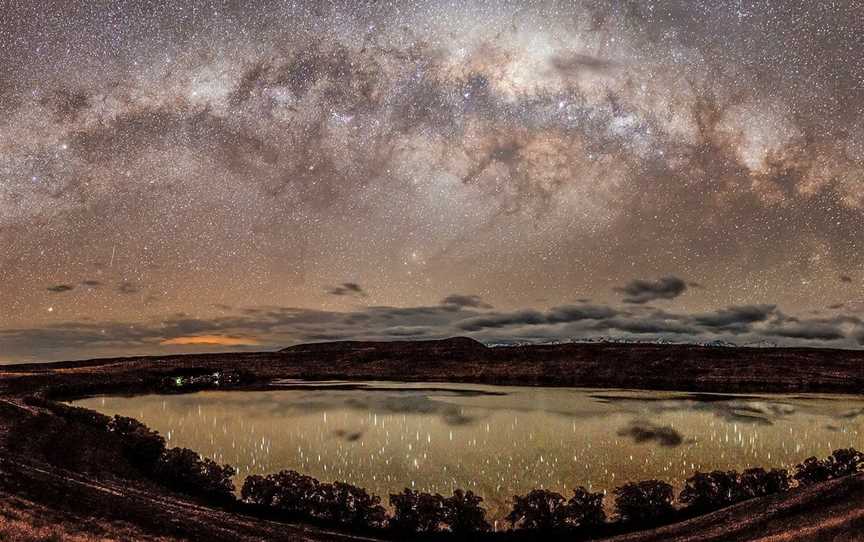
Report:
25,396,864,536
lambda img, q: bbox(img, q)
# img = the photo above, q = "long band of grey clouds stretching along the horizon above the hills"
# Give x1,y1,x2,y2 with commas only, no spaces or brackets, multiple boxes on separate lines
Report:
0,304,864,366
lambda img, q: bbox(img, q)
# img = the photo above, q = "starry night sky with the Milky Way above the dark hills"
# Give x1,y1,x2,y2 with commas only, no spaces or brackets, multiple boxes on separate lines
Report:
0,0,864,363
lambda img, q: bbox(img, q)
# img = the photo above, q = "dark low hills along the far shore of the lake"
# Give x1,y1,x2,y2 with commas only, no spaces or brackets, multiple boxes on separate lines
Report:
0,338,864,399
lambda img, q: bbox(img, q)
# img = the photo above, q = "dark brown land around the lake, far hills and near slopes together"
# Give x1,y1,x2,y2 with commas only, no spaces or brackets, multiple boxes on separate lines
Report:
0,339,864,542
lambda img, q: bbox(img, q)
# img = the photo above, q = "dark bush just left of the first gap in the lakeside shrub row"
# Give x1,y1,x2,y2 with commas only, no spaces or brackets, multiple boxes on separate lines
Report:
155,448,235,504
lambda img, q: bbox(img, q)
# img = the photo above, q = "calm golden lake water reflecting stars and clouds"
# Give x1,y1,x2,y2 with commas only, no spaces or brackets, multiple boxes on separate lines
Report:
76,381,864,518
